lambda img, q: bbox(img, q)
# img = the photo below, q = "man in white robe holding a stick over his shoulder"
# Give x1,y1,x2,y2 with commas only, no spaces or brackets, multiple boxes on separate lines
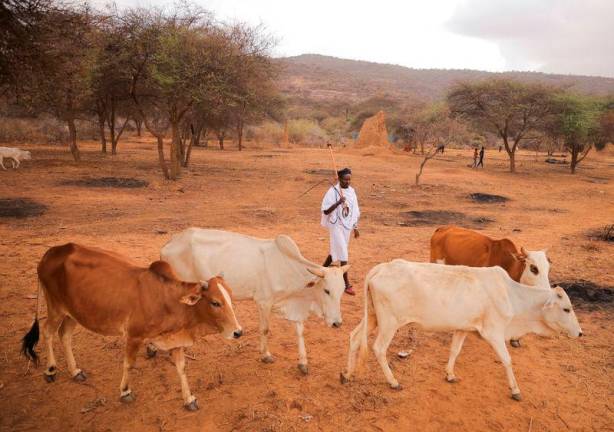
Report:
321,168,360,295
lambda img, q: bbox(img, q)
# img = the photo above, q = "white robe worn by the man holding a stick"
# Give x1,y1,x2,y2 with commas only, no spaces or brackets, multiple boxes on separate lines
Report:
320,183,360,261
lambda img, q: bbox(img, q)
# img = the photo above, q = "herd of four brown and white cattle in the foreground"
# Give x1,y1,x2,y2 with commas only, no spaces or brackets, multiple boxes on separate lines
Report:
22,227,582,410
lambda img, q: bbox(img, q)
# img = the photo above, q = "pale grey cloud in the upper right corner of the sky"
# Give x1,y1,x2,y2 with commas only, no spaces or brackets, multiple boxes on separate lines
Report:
448,0,614,77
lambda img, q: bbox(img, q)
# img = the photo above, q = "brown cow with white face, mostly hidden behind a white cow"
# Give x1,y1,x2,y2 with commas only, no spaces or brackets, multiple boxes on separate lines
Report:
431,226,550,347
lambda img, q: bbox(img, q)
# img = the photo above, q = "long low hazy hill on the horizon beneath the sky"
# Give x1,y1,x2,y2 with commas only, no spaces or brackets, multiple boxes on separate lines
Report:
279,54,614,105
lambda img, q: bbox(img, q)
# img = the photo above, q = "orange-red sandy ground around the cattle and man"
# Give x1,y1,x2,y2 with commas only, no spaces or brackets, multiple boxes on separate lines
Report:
0,138,614,431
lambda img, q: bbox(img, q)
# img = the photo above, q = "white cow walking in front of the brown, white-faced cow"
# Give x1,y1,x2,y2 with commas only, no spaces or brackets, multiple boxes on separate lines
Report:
341,259,582,400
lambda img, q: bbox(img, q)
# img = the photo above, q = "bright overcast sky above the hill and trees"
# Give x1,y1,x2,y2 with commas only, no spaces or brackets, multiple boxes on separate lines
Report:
102,0,614,77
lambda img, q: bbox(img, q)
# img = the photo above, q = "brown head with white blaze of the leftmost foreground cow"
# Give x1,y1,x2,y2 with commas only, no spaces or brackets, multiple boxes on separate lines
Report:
181,276,243,339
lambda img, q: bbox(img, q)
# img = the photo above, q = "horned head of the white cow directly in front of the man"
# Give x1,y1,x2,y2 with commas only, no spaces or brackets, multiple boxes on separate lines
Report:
307,264,350,328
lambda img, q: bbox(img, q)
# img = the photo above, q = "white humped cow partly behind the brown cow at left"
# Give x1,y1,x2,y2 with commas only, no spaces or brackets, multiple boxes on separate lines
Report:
160,228,349,374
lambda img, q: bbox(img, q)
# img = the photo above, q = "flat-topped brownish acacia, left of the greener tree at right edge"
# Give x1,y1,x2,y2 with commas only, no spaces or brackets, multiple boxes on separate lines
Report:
447,79,553,172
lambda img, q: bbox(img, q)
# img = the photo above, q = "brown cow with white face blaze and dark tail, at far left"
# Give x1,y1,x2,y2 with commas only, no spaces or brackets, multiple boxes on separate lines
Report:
22,243,242,411
